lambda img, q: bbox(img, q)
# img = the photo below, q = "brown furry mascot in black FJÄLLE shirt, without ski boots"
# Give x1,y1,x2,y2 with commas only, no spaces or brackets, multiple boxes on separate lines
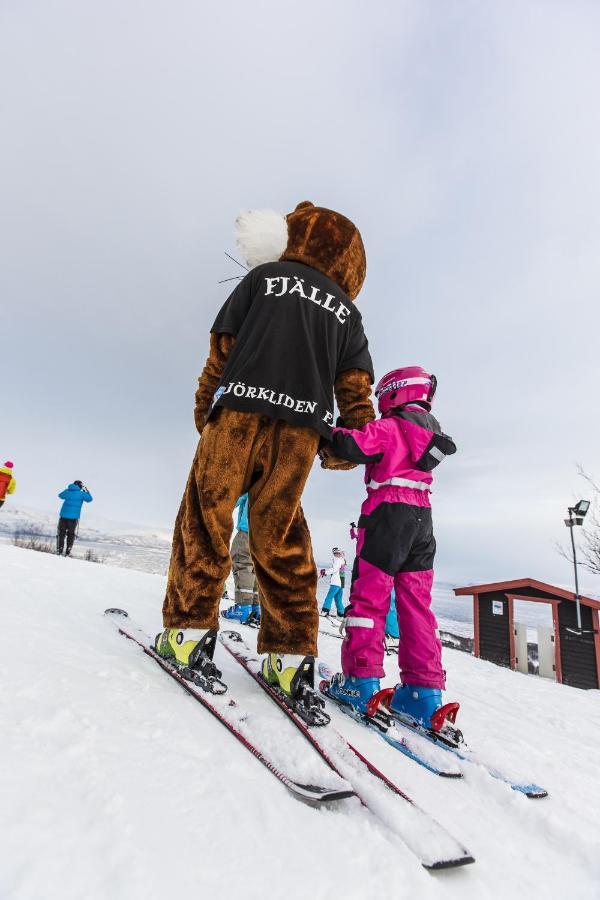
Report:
163,202,374,656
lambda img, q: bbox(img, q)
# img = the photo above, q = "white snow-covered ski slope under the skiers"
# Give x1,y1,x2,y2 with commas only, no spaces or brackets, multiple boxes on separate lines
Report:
0,546,600,900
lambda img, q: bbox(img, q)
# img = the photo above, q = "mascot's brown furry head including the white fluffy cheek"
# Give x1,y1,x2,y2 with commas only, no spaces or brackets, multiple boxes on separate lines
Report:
236,200,367,300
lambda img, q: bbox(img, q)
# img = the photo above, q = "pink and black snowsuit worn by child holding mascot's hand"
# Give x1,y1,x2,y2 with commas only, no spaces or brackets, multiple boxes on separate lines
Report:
333,403,456,689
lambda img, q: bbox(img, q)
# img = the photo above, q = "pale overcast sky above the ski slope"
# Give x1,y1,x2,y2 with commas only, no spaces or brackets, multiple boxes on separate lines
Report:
0,0,600,591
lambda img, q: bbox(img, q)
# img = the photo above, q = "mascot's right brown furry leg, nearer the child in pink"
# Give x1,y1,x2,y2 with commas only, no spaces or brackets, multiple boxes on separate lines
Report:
248,419,319,656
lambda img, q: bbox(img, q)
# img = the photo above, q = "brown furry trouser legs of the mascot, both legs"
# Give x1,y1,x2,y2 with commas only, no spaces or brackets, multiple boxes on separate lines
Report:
163,409,319,655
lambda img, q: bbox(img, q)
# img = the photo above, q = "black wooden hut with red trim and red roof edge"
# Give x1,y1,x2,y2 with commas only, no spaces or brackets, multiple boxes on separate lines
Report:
454,578,600,689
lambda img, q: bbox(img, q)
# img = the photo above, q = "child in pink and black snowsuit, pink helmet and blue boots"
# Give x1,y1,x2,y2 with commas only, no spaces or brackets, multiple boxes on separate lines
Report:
321,366,456,730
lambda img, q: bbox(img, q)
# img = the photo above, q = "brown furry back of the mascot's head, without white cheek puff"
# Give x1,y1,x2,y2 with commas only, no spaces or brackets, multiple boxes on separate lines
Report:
281,200,367,300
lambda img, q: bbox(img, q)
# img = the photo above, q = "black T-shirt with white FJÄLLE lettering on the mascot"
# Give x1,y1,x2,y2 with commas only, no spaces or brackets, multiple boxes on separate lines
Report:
211,262,374,438
